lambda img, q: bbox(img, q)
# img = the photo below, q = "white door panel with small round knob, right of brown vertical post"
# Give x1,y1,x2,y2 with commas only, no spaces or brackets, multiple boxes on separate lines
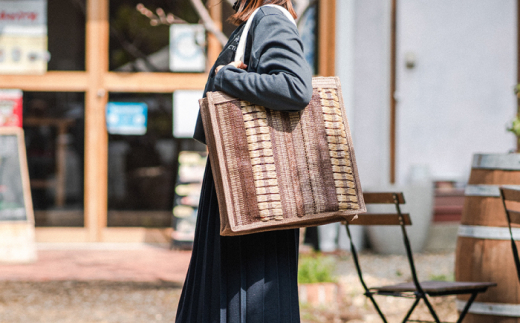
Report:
397,0,517,182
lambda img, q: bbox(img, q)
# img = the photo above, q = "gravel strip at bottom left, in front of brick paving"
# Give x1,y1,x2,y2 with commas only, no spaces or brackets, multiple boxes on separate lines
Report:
0,281,181,323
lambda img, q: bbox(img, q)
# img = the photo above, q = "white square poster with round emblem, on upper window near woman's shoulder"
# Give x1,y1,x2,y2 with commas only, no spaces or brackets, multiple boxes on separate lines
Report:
170,24,206,72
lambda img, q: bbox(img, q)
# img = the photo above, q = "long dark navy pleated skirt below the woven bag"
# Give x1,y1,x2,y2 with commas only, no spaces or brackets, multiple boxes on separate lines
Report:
175,160,300,323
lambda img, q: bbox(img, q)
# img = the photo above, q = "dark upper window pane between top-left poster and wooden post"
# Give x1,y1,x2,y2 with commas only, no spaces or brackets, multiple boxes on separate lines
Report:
47,0,86,71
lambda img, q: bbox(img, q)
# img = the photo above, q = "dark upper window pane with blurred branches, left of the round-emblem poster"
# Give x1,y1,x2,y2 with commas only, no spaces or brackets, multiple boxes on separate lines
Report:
110,0,199,72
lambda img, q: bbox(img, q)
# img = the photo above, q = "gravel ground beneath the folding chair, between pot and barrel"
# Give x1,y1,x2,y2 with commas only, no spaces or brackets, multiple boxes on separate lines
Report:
301,252,458,323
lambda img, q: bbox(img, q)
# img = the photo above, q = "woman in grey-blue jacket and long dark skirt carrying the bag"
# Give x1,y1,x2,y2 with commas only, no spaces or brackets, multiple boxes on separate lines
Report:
176,0,312,323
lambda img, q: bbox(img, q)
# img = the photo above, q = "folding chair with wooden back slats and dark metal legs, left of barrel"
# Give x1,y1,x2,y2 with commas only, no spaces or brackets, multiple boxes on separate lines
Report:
345,192,497,323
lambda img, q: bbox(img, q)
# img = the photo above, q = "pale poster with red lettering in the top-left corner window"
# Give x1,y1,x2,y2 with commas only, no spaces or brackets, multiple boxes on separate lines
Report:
0,0,49,74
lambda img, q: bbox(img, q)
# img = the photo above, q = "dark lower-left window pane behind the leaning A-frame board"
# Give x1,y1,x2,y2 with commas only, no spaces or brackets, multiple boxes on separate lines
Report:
23,92,85,227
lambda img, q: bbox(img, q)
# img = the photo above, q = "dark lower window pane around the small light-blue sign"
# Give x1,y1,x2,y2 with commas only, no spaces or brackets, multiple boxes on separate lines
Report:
107,93,205,227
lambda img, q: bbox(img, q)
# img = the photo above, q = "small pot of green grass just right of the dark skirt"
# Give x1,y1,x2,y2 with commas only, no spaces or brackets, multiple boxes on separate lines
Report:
298,253,339,309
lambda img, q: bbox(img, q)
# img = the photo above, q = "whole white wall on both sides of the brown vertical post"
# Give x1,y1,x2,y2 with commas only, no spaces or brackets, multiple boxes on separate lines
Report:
336,0,516,189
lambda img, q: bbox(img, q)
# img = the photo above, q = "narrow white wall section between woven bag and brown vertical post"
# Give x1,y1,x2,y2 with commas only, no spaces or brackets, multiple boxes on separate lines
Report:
336,0,390,189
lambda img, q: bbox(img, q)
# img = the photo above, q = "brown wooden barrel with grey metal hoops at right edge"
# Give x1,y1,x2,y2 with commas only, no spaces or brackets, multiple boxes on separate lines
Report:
455,154,520,323
